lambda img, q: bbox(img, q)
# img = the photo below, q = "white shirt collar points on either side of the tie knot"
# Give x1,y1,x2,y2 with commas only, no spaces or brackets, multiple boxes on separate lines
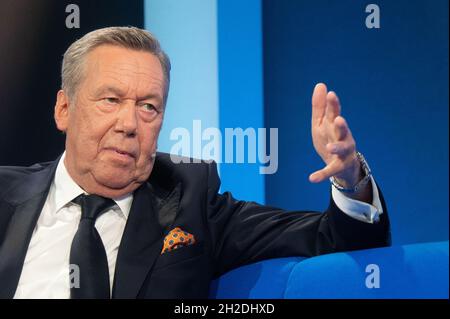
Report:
54,152,133,218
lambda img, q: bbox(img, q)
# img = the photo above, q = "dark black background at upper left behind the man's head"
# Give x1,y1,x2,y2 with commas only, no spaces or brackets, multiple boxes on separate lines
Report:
0,0,144,165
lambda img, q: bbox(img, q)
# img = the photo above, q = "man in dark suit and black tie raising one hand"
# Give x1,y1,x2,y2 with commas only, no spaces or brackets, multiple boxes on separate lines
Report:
0,27,390,298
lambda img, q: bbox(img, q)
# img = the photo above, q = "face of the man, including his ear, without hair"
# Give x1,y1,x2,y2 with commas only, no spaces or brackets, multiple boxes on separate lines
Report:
55,45,164,197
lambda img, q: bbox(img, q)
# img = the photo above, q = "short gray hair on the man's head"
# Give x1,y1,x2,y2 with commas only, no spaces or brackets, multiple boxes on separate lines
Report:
61,27,170,104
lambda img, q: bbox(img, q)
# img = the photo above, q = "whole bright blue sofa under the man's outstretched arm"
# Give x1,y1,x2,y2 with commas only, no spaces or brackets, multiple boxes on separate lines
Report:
210,241,449,299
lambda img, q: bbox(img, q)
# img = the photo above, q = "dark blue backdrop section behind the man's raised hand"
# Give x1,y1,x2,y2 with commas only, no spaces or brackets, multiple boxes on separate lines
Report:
263,0,449,244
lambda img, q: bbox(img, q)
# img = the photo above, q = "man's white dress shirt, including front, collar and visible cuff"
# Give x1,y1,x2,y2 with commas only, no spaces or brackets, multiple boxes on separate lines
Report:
14,153,383,299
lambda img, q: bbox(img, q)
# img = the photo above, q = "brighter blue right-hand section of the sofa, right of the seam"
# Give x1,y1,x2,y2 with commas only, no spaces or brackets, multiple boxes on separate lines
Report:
285,241,449,298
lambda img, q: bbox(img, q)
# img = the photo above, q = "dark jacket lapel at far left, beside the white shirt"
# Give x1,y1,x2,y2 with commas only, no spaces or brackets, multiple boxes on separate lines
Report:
0,162,59,298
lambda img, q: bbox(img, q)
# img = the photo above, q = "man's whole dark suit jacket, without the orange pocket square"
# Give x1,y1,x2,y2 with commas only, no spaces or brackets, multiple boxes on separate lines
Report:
0,153,390,298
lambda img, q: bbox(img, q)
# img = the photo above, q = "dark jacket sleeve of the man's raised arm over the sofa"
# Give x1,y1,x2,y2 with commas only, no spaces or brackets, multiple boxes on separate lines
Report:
207,163,390,276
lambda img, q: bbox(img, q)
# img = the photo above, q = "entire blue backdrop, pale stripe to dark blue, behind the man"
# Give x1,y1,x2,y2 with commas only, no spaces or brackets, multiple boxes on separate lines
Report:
145,0,449,244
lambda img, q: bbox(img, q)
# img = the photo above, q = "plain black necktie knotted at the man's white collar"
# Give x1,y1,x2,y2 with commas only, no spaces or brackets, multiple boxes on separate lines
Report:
70,195,114,299
